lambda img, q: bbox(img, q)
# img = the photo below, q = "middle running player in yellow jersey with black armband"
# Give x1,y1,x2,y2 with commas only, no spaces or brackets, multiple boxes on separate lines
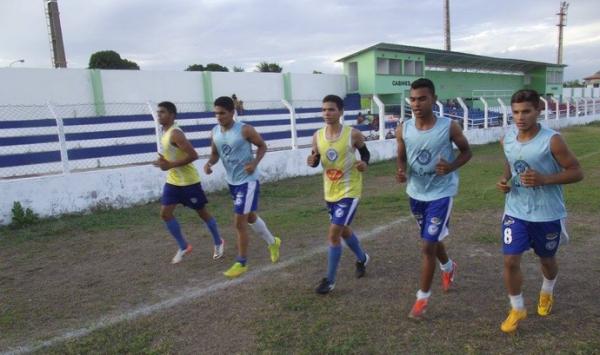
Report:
307,95,370,294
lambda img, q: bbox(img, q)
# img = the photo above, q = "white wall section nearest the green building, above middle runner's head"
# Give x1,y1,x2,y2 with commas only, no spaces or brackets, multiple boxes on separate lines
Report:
290,74,347,107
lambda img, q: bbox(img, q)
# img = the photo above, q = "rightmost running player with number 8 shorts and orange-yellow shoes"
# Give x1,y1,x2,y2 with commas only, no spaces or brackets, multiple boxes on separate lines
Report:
496,90,583,333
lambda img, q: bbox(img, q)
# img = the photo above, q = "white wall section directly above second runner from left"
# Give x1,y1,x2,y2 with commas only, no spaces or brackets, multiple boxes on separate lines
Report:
211,72,284,109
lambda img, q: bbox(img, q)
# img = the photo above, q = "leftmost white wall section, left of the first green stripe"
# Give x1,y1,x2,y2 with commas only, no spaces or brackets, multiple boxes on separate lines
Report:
0,68,94,105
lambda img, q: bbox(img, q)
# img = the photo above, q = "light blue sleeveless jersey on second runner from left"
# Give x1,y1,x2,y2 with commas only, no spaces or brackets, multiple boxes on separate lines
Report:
212,122,258,185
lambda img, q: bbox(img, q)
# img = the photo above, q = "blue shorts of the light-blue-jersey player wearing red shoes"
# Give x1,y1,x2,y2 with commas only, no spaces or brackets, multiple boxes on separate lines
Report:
410,197,452,243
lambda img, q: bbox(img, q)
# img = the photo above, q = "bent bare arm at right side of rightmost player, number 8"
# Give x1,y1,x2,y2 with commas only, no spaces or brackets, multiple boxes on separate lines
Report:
521,134,583,187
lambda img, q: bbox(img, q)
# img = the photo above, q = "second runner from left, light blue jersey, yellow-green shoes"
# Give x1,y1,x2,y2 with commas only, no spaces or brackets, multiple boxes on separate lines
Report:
204,96,281,278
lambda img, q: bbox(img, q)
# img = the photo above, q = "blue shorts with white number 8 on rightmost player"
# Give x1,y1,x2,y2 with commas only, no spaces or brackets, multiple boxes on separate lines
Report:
502,215,568,258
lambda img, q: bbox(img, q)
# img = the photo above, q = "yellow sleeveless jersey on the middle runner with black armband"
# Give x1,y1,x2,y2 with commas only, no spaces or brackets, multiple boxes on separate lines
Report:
317,126,362,202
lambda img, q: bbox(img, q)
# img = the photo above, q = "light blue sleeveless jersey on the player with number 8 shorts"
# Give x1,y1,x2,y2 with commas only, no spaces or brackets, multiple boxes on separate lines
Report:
504,125,567,222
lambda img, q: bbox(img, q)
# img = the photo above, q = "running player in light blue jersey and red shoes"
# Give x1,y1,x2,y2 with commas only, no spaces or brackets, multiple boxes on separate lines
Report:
396,79,471,319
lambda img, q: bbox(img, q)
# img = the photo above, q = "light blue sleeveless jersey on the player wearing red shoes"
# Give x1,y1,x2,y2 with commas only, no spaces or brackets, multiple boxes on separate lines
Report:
402,117,458,201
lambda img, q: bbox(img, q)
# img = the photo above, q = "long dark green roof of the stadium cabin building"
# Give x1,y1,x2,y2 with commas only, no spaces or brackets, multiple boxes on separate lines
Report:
337,43,566,72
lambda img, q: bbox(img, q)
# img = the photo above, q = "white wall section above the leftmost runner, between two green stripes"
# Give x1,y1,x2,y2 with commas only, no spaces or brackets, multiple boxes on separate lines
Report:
100,70,204,103
